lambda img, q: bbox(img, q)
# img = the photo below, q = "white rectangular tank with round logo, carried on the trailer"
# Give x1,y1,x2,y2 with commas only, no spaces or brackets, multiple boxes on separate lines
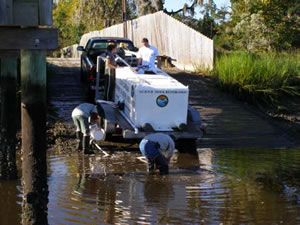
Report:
114,67,189,131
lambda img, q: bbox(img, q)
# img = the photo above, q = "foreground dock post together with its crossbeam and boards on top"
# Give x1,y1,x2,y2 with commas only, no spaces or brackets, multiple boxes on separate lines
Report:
0,0,57,225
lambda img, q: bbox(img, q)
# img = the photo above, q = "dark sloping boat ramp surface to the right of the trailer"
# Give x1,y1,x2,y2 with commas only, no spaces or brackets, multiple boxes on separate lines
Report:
168,69,300,148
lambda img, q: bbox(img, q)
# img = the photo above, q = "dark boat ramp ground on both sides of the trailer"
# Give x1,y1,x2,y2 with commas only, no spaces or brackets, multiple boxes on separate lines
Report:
47,59,300,154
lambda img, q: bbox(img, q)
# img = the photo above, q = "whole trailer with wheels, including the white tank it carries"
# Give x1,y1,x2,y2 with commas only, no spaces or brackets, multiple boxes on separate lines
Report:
94,52,203,151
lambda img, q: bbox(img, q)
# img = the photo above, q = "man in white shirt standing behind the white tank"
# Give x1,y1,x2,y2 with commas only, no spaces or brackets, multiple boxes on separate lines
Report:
137,38,161,69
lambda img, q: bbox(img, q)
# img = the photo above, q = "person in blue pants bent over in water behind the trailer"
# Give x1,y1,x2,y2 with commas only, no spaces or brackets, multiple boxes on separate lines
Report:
139,133,175,175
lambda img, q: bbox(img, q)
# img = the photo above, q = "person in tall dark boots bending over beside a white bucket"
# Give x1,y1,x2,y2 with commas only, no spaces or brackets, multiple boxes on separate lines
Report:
72,103,100,154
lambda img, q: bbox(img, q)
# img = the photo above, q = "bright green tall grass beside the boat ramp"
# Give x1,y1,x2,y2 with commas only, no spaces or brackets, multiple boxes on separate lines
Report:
211,52,300,106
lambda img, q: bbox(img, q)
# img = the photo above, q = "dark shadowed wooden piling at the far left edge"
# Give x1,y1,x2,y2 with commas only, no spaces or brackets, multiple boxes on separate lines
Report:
0,58,18,179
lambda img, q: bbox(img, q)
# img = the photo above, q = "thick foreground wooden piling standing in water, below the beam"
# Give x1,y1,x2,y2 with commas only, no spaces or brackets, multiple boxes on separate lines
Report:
21,50,48,224
